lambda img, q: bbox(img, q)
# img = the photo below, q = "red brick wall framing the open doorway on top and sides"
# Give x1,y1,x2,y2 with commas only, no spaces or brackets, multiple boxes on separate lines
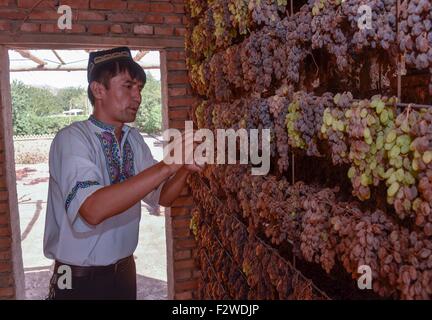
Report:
0,0,199,299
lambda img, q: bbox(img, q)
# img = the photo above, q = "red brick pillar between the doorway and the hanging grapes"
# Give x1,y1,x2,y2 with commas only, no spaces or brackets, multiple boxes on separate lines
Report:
165,48,198,299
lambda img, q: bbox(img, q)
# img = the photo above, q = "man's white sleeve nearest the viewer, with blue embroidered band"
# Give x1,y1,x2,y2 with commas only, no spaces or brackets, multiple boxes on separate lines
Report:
49,128,104,231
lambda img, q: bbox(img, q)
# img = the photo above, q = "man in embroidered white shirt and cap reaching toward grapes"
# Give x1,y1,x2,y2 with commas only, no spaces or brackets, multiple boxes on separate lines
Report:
44,47,200,299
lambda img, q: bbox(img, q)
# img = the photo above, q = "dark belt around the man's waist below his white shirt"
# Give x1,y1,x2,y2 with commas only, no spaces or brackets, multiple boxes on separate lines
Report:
54,256,134,277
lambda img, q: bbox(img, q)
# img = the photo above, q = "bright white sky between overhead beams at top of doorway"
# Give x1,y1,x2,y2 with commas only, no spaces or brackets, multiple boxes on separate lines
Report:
9,50,160,88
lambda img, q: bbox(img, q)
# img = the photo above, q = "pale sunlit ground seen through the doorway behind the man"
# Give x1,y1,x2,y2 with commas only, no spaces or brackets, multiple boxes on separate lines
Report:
15,138,167,300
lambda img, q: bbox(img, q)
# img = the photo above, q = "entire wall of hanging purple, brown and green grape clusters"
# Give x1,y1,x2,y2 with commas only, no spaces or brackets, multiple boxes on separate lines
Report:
185,0,432,299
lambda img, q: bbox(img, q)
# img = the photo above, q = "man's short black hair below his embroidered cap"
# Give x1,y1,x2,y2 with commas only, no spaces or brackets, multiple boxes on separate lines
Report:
87,59,146,106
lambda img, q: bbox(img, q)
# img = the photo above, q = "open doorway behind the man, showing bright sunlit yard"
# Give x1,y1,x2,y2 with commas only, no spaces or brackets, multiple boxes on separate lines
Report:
9,49,167,299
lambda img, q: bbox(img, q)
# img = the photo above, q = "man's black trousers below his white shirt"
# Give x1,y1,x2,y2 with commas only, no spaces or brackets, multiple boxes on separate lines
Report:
48,256,137,300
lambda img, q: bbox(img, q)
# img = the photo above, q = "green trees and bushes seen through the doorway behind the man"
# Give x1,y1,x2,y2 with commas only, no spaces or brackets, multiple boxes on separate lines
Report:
11,73,162,135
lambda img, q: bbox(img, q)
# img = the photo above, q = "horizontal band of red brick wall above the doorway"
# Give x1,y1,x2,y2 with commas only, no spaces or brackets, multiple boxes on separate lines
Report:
0,0,186,37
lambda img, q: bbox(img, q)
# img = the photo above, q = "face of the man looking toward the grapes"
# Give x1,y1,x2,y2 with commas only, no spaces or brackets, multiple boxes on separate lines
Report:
102,72,144,123
